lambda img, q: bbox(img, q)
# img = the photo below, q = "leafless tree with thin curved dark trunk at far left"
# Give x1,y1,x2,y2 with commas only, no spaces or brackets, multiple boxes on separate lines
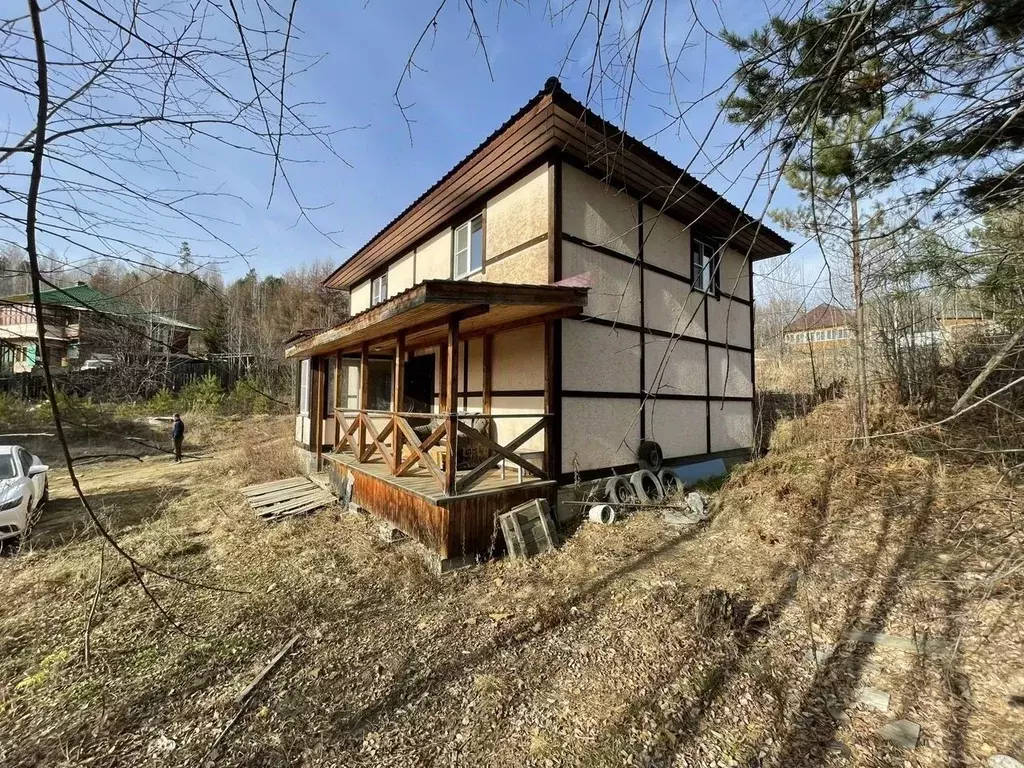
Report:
0,0,348,631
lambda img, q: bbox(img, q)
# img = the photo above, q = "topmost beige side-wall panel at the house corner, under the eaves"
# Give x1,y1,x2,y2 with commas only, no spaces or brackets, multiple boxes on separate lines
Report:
562,165,639,256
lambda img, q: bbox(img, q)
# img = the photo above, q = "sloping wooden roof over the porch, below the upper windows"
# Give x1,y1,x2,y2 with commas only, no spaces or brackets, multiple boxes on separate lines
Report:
285,280,587,357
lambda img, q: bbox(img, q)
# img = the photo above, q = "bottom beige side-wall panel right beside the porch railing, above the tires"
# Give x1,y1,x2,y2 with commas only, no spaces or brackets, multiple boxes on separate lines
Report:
562,397,640,472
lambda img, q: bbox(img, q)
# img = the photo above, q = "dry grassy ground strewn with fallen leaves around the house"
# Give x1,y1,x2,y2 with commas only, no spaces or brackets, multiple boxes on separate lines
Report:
0,404,1024,768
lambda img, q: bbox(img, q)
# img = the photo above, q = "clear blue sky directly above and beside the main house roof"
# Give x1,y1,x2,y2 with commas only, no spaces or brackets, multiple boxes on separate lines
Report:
0,0,813,294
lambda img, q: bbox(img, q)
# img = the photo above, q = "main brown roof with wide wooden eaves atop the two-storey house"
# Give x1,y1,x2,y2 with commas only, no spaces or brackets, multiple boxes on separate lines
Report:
325,78,793,288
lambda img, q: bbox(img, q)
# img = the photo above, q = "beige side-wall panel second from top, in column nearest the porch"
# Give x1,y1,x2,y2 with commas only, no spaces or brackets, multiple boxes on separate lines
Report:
562,242,640,326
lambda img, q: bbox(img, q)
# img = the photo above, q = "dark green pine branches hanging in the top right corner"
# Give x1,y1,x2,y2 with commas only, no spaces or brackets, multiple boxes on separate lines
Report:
725,0,1024,210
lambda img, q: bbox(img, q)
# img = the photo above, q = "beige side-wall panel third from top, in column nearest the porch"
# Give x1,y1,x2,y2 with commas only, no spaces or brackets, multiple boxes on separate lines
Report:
562,319,640,393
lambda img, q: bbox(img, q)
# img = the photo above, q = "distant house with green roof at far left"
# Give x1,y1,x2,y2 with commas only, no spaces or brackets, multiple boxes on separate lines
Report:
0,283,202,374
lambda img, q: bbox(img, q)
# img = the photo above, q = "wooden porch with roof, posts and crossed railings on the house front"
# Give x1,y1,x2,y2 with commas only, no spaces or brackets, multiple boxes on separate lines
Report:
288,281,586,561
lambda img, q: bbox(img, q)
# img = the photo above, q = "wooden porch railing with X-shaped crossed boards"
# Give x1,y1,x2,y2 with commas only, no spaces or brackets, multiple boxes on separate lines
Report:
334,409,552,496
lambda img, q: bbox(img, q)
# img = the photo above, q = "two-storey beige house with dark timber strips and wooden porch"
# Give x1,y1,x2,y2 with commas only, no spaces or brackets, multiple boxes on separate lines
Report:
287,79,791,563
